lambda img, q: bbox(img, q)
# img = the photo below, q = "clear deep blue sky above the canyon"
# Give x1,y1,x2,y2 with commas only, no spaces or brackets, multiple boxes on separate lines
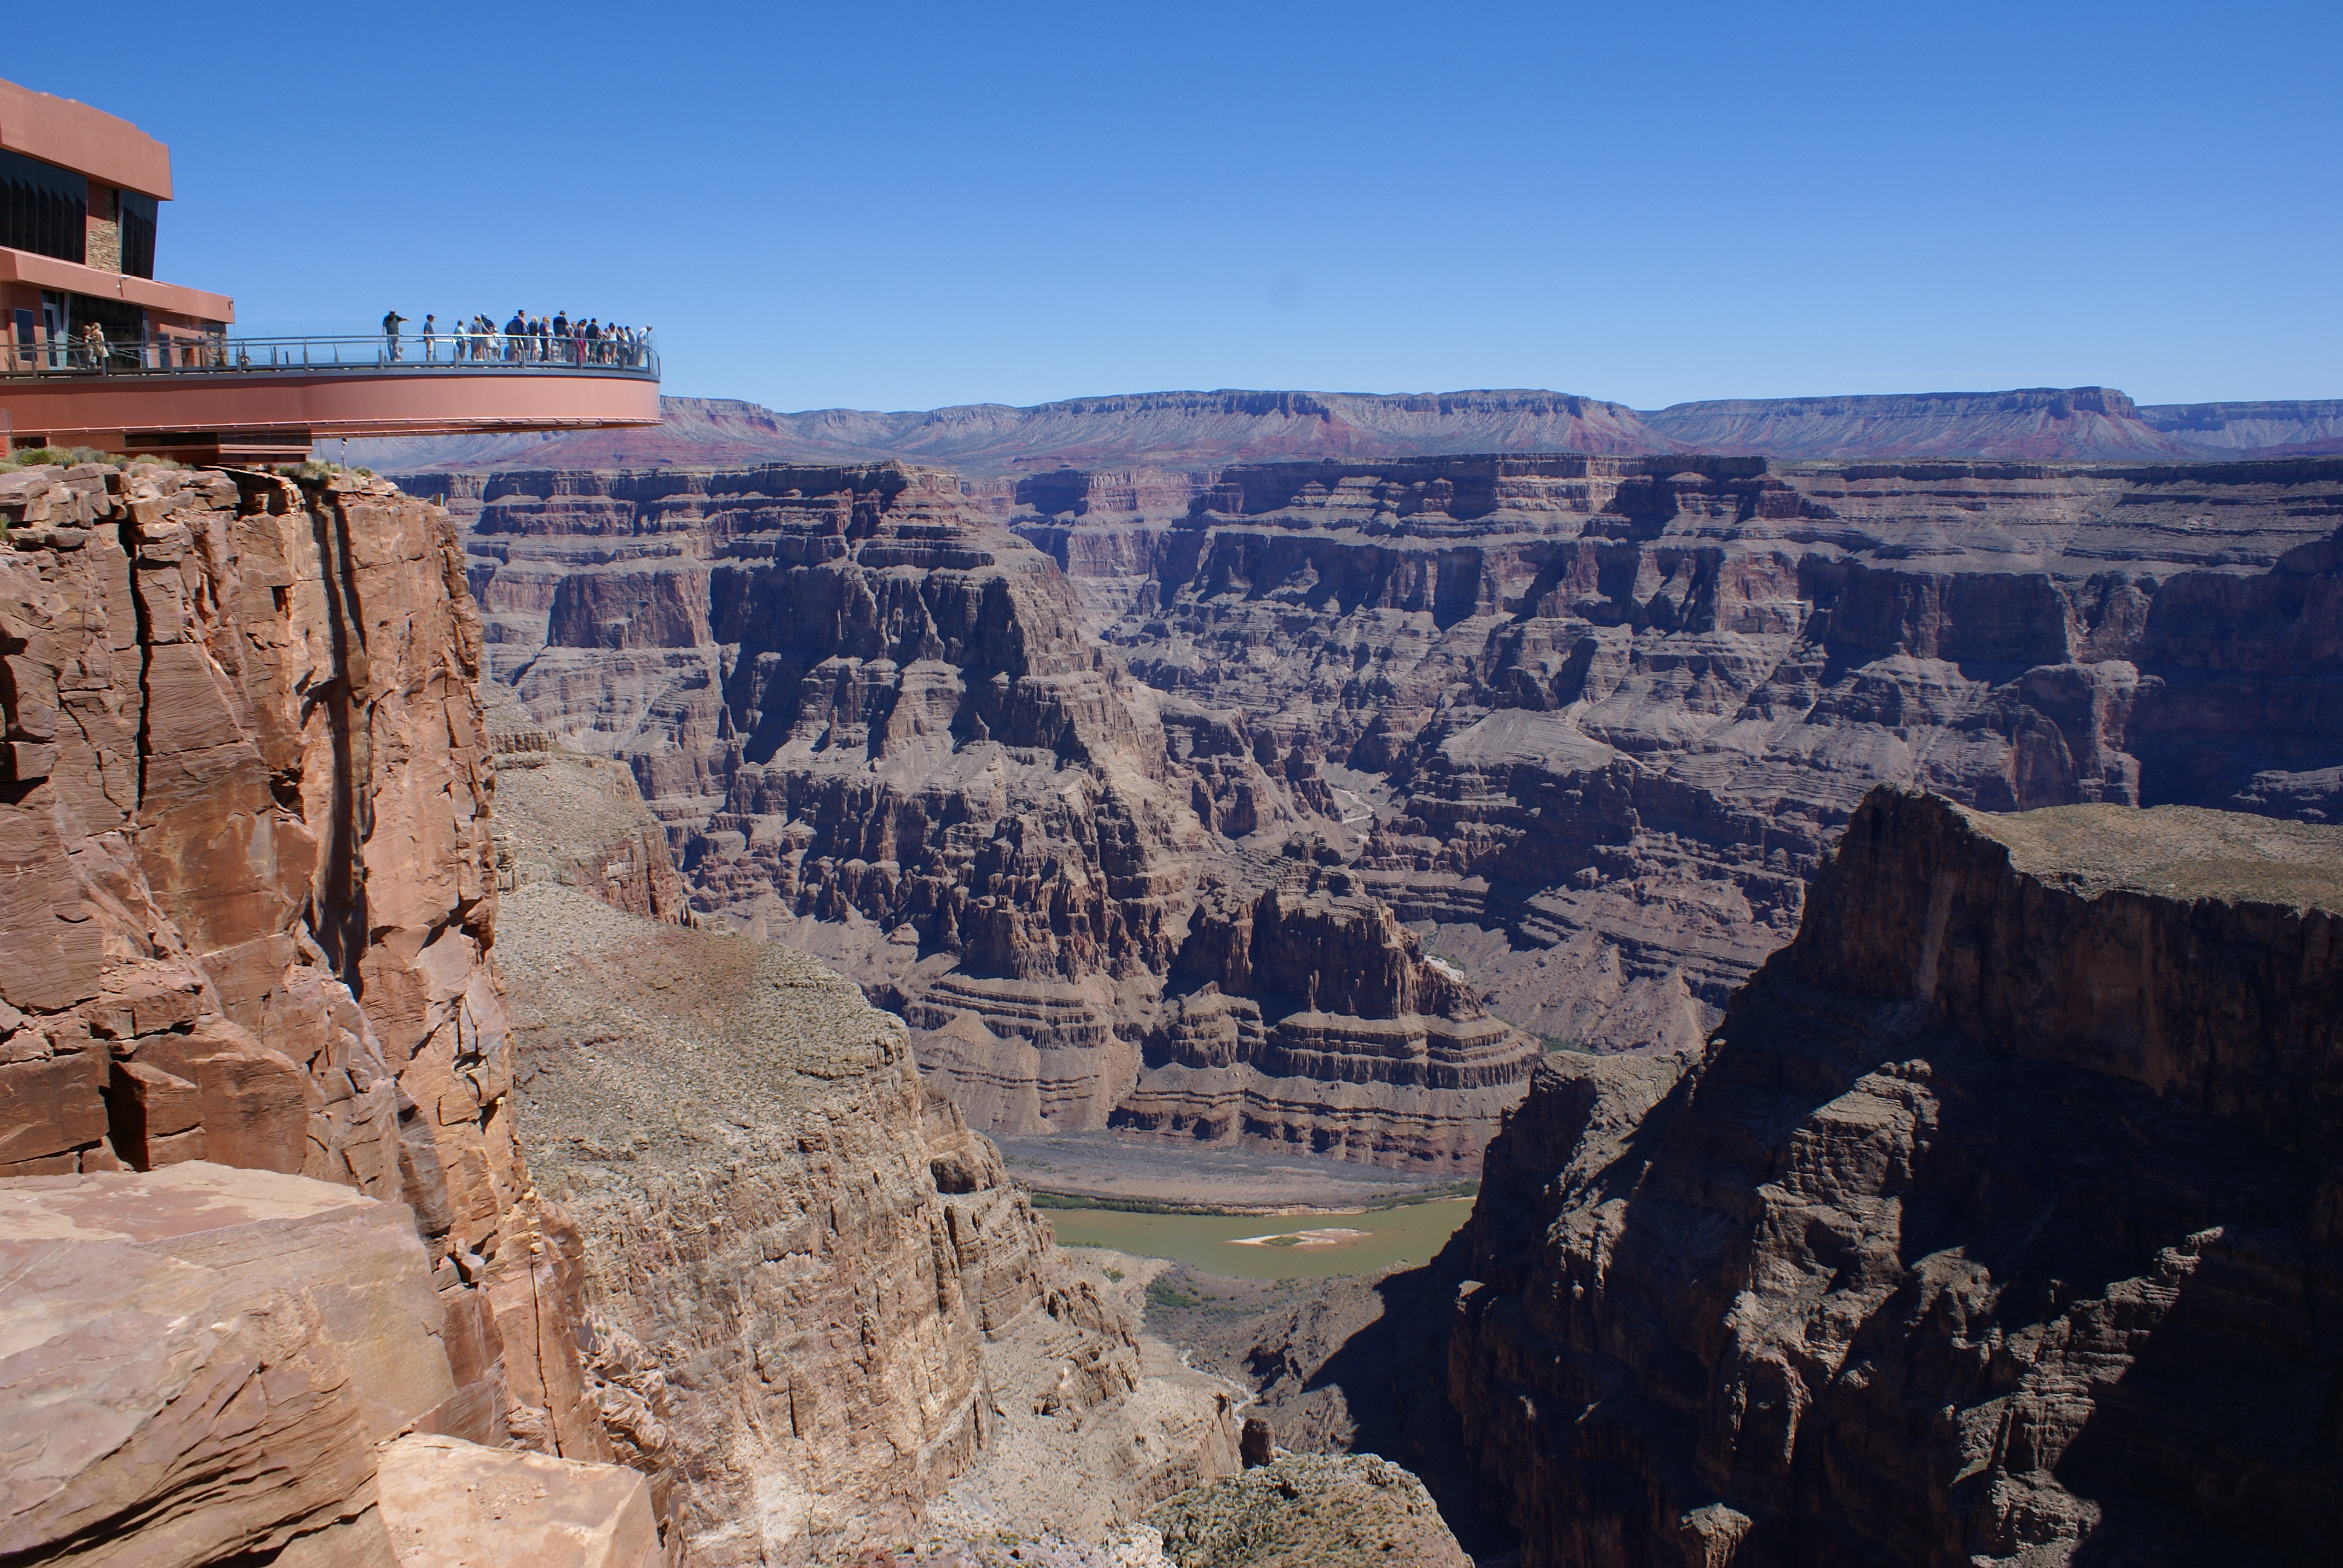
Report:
36,0,2343,410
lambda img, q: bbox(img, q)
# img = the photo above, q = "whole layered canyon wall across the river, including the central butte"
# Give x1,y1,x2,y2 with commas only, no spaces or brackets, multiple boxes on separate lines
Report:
442,455,2343,1165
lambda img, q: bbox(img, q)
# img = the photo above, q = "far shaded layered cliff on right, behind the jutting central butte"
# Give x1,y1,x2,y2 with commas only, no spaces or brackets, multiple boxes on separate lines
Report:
1073,457,2343,1050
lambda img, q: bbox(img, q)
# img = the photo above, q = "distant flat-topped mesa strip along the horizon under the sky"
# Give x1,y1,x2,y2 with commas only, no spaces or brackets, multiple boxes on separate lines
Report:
349,387,2343,478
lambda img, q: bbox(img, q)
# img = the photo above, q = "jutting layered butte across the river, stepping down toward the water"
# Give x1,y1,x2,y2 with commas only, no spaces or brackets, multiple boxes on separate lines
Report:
471,466,1537,1169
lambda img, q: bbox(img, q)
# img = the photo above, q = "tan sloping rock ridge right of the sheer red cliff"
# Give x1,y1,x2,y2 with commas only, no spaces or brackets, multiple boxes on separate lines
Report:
497,753,1235,1566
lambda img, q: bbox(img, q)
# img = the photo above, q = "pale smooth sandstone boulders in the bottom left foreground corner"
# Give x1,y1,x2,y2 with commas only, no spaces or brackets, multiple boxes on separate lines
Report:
0,1160,666,1568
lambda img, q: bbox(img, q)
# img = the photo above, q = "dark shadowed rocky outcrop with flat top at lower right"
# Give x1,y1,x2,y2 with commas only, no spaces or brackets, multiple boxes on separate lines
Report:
1443,790,2343,1568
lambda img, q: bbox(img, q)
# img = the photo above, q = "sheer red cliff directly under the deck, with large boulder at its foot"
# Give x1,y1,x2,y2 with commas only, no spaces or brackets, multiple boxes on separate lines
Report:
0,464,668,1561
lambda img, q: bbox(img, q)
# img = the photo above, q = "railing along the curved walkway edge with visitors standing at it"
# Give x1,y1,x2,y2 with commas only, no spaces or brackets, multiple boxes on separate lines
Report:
0,333,658,382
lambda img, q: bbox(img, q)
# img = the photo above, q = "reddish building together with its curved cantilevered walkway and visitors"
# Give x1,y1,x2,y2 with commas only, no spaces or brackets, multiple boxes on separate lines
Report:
0,82,658,462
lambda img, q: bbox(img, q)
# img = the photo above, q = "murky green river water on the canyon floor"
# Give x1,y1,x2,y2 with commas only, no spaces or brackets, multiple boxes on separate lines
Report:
1045,1198,1472,1279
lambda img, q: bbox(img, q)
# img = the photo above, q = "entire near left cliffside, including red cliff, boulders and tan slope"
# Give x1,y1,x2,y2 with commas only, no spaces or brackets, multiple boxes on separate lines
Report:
0,466,1235,1568
